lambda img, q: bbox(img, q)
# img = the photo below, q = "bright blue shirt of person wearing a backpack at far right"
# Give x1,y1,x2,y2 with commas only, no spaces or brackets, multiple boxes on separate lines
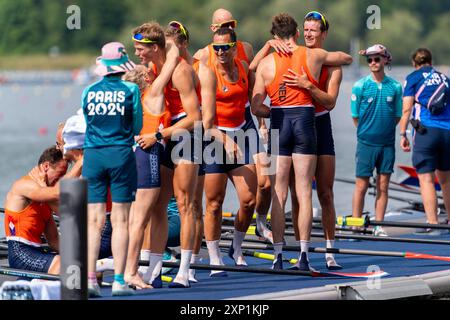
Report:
403,66,450,130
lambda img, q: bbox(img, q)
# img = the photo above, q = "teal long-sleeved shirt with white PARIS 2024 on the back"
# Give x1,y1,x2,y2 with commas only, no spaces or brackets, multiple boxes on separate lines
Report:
81,76,142,148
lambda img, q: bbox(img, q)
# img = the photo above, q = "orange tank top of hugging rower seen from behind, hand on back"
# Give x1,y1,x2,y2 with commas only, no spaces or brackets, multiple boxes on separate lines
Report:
266,46,317,108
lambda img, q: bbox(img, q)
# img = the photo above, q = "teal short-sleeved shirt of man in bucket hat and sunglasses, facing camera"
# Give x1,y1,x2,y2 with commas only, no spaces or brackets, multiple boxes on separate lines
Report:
351,75,402,146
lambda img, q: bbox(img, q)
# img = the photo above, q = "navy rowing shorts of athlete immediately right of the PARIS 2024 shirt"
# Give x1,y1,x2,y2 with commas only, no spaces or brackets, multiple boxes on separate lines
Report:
134,142,164,189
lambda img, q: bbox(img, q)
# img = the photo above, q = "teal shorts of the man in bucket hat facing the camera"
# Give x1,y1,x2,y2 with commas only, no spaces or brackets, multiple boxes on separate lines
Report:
356,141,395,177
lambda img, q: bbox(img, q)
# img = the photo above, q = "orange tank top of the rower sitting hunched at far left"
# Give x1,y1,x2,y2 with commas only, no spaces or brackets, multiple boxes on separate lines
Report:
5,194,52,247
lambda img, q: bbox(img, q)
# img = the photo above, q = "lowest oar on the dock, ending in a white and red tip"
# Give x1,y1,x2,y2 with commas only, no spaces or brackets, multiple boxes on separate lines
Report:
139,261,388,278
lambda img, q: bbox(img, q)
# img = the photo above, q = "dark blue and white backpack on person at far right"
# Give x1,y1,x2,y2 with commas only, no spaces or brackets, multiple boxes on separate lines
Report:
415,69,449,115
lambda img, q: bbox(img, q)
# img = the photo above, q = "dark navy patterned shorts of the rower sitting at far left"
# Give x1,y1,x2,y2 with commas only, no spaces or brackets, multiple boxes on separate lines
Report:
8,240,56,273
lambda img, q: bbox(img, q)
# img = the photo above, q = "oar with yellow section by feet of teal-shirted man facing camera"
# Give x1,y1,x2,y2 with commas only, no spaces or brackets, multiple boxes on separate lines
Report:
320,216,450,230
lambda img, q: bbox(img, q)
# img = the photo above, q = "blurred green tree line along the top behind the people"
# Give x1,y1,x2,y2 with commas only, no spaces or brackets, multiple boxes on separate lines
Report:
0,0,450,64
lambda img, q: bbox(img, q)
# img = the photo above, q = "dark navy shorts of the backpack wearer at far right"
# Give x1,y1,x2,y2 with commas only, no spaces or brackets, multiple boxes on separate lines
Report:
412,127,450,173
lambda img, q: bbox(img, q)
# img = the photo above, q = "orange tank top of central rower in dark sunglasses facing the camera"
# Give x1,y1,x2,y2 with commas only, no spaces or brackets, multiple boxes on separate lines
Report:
210,53,248,130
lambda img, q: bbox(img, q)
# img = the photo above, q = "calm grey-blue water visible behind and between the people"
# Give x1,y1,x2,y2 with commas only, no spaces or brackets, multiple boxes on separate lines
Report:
0,68,428,235
